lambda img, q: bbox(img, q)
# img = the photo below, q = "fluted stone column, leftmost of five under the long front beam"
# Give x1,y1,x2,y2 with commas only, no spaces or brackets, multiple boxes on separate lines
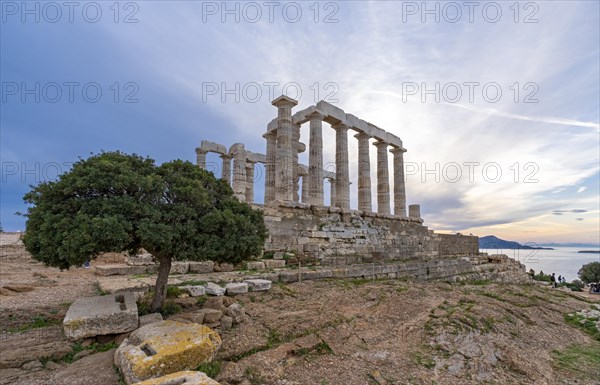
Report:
310,112,323,206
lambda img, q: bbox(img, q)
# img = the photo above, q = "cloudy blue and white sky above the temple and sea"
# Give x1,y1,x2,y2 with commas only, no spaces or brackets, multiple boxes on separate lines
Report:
0,1,600,243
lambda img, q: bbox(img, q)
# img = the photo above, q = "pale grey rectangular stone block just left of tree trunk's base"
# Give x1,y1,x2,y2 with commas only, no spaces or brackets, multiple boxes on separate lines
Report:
63,292,138,340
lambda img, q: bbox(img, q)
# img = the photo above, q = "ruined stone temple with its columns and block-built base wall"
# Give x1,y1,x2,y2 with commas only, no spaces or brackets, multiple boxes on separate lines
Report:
196,96,479,265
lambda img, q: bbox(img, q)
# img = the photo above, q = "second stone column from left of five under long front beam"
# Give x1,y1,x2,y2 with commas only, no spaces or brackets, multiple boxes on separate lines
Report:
332,123,350,210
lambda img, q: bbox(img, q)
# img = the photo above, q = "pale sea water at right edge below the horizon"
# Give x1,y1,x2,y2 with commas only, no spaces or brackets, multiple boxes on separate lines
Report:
480,247,600,282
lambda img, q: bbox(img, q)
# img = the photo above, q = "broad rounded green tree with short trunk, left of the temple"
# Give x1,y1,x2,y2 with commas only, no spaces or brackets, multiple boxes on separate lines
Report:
23,152,267,311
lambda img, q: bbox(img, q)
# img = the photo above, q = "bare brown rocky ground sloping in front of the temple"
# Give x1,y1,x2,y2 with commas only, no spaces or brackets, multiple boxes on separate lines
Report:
0,234,600,385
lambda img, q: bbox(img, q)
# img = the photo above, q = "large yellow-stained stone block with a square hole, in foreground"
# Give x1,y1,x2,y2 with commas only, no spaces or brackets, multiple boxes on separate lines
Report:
115,321,221,384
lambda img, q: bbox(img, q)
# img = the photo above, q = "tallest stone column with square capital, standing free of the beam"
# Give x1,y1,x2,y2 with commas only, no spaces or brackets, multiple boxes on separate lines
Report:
271,95,298,201
